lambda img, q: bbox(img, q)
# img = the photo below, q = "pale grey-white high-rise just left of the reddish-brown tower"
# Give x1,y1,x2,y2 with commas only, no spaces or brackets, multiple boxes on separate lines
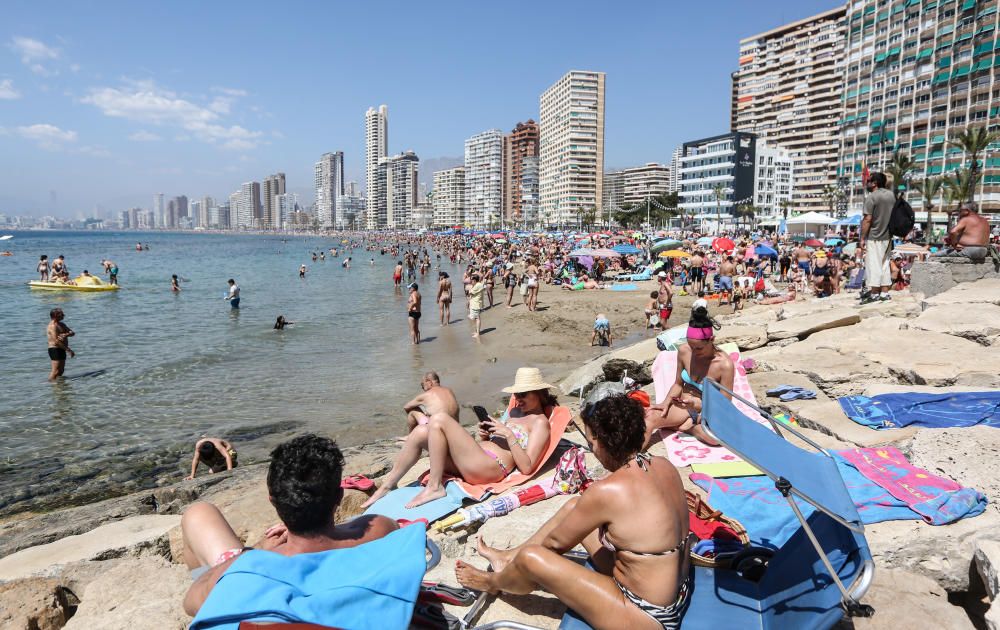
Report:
465,129,503,227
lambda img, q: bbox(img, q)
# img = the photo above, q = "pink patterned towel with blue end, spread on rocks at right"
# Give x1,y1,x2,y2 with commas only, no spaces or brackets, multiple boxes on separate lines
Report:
837,446,986,525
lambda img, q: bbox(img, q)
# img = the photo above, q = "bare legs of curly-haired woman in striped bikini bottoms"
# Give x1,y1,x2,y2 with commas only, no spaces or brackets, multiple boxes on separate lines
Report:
455,545,660,629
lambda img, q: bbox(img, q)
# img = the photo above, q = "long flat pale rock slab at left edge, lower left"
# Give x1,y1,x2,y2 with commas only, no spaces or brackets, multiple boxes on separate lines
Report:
0,515,181,580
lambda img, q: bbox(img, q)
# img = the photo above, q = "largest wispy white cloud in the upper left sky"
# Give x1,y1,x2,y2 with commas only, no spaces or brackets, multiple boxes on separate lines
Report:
83,81,262,150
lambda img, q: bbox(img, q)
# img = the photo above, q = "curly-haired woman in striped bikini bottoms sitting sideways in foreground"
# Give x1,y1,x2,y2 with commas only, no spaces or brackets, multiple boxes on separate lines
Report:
455,394,691,629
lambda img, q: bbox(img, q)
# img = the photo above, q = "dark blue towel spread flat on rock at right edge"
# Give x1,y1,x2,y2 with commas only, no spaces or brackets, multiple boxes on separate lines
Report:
838,391,1000,429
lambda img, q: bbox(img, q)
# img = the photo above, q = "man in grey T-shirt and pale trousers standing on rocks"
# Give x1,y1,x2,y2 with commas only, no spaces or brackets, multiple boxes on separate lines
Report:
858,173,896,304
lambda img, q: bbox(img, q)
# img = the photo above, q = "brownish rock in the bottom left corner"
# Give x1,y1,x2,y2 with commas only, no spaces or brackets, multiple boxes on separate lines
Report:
0,578,77,630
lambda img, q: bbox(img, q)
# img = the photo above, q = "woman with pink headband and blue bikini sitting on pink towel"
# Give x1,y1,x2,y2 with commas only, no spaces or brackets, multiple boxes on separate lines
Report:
646,306,736,448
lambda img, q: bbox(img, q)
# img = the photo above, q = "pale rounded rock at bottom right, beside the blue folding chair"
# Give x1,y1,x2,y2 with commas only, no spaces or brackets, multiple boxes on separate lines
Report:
841,569,975,630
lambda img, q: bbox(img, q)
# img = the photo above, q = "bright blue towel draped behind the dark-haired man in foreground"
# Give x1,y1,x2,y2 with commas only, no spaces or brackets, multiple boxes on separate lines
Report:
190,526,427,630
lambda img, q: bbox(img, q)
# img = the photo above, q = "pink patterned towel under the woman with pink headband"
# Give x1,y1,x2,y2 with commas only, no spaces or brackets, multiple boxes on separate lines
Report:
653,346,767,467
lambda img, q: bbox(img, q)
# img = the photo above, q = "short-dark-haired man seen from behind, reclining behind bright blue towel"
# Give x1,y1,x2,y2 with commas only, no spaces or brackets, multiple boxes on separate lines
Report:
181,435,398,616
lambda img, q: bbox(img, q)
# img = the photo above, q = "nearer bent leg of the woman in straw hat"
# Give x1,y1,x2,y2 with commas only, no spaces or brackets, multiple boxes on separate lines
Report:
406,413,503,508
